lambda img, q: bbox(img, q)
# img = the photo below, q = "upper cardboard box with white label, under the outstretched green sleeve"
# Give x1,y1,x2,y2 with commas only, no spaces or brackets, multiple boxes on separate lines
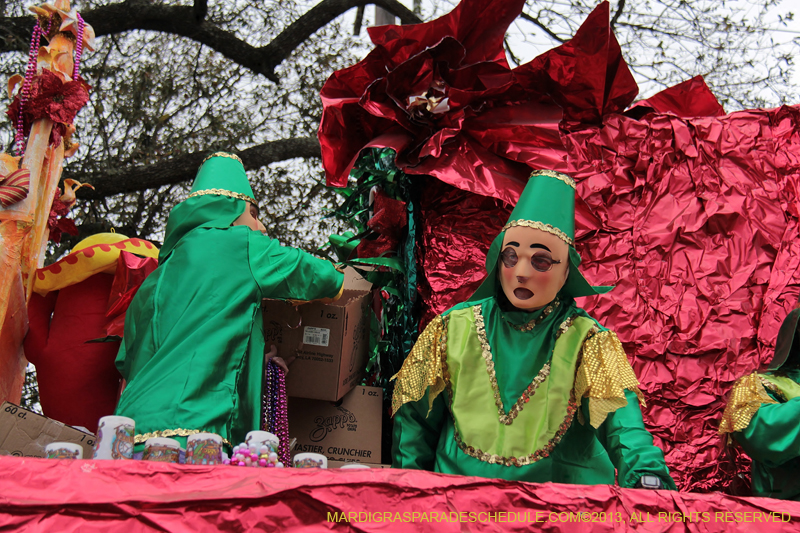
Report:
264,269,371,401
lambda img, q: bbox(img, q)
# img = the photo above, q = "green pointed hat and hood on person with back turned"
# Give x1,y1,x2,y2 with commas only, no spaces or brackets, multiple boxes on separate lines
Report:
158,152,258,262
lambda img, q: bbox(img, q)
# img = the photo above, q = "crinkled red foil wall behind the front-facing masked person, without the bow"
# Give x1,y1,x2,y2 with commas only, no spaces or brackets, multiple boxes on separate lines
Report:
420,102,800,491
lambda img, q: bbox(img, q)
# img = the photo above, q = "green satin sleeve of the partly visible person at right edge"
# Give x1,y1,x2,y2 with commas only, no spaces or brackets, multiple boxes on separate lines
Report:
733,398,800,468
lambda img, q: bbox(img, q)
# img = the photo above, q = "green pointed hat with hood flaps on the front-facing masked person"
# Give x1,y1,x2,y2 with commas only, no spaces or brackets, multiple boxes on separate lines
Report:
469,170,614,301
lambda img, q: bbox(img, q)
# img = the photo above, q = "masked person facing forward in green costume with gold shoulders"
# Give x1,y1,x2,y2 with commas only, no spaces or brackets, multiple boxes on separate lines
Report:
392,170,675,489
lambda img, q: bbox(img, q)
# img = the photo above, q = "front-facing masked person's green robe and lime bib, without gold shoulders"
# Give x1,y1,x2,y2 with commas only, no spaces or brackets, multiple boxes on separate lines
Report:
392,298,675,489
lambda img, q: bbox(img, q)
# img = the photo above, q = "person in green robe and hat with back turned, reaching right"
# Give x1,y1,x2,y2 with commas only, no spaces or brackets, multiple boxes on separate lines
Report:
116,152,344,450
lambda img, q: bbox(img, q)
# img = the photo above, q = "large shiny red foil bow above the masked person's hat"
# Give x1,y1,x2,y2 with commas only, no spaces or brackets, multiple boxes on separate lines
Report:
319,0,637,204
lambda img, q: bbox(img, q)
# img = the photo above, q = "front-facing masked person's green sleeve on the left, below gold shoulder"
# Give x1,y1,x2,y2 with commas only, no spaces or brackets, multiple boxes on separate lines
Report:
392,391,447,471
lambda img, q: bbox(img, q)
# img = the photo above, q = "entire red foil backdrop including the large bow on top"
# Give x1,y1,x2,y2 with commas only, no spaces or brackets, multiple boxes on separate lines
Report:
320,0,800,492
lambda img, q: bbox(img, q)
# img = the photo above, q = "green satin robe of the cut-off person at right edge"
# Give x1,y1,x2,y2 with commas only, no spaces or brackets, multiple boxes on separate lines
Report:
733,370,800,500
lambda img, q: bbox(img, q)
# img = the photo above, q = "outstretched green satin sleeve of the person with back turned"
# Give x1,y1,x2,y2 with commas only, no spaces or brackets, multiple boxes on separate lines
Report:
248,231,344,301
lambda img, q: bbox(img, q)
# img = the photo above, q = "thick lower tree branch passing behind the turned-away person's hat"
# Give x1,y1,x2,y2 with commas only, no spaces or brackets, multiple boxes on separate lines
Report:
71,137,321,198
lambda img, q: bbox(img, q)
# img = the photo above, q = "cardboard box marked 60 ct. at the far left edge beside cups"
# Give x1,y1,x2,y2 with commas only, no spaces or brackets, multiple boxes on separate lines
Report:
0,402,95,459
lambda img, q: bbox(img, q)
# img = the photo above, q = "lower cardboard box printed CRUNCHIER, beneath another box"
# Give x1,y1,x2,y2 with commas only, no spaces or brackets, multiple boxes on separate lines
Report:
289,385,383,464
